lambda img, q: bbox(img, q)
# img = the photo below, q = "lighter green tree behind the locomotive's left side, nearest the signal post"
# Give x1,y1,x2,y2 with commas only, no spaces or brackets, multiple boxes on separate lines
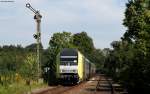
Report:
44,32,74,85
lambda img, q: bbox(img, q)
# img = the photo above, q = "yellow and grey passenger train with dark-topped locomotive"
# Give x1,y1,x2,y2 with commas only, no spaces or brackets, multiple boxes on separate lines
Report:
56,48,96,84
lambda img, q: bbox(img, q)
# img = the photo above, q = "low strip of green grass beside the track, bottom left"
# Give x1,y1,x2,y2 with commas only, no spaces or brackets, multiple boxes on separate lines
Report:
0,83,47,94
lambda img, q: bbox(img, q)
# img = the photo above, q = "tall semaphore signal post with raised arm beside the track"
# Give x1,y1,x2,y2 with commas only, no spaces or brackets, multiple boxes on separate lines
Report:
26,3,42,79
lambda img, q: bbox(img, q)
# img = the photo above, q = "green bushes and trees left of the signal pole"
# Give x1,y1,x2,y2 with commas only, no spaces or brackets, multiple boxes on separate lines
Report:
0,45,41,86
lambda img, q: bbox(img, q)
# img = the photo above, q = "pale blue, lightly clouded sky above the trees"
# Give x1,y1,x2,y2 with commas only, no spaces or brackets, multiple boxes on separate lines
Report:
0,0,127,49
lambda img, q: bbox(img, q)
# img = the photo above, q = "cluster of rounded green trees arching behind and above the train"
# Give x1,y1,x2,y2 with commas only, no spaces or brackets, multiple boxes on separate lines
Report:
44,32,104,84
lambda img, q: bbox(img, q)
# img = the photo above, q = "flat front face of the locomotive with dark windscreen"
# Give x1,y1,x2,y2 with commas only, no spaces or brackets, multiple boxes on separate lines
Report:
59,48,79,83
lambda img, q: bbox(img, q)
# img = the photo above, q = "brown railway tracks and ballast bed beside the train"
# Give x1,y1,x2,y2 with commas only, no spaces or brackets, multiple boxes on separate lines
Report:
32,75,128,94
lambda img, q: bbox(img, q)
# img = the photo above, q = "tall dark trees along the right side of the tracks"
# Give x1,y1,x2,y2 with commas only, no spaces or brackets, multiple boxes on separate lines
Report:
105,0,150,94
